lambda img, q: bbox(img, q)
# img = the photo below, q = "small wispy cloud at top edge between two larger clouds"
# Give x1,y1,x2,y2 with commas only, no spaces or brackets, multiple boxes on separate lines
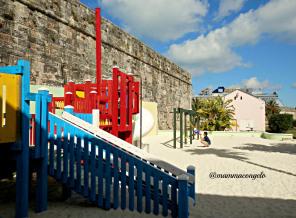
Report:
215,0,245,20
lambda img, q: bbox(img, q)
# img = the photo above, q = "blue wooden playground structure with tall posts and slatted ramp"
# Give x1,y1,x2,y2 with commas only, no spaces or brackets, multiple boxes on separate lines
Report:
0,61,195,218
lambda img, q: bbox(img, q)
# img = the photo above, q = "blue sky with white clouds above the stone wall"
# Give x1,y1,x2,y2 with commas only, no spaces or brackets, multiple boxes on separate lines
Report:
81,0,296,107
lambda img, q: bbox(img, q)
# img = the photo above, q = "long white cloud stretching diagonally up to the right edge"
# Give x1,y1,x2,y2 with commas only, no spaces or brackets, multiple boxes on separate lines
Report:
167,0,296,75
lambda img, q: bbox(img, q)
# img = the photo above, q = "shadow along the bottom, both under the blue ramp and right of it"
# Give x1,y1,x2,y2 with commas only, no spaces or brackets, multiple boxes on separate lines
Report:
0,179,296,218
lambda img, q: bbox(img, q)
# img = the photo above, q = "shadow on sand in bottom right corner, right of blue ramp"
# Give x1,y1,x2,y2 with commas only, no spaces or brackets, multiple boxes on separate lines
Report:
190,194,296,218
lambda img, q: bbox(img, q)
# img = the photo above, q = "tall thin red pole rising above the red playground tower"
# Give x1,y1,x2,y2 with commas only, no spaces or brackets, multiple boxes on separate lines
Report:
96,8,102,101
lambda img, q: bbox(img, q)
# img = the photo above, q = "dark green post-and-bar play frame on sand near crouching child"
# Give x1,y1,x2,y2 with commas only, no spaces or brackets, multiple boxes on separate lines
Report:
174,108,198,148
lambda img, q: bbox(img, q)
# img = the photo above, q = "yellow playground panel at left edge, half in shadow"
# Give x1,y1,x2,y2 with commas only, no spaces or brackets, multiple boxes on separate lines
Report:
0,73,21,144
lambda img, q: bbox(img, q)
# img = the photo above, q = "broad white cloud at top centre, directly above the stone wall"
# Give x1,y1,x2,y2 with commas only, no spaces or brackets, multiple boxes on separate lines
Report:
102,0,208,41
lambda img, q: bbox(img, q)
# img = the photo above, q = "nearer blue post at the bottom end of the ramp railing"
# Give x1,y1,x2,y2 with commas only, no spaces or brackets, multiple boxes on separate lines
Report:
177,174,189,218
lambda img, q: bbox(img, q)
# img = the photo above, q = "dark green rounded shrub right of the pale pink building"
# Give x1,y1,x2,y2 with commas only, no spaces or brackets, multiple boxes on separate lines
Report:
268,114,293,133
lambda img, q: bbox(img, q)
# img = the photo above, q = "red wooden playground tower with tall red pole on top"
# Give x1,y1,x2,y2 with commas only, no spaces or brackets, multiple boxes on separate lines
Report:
50,8,140,143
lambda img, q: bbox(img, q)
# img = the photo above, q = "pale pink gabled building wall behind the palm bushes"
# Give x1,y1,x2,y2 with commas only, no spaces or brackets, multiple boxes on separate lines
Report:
225,90,265,131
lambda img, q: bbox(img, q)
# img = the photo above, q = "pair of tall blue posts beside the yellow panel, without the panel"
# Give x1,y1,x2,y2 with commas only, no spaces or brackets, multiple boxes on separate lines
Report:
0,60,51,218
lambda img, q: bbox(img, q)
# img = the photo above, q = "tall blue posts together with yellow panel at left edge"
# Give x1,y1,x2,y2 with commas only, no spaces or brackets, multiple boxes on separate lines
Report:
0,60,51,217
